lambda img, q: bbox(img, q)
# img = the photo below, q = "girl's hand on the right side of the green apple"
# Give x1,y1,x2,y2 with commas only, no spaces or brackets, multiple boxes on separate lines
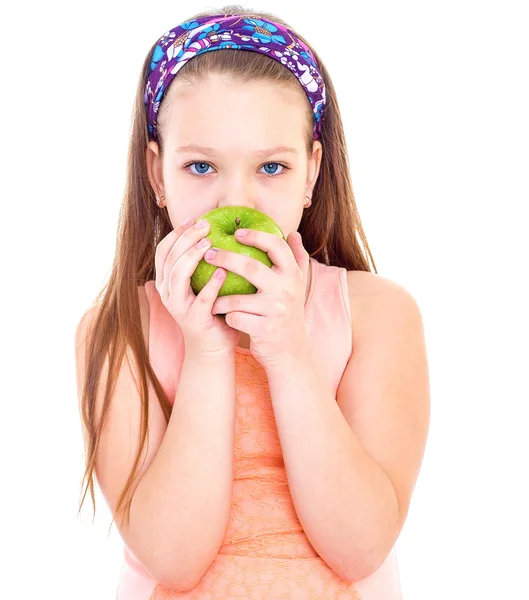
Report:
204,229,310,368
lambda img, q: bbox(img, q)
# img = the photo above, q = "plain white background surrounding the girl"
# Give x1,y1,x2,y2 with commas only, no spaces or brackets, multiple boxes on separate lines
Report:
0,0,529,600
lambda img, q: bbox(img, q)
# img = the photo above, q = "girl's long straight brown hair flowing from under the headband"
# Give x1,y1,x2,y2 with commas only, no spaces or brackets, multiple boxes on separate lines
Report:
79,5,377,527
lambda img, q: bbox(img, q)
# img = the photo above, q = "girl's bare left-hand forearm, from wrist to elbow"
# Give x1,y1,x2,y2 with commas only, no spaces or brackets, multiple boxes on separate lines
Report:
122,353,235,591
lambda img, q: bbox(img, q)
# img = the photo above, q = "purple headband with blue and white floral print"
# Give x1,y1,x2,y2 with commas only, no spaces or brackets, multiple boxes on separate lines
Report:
143,15,325,140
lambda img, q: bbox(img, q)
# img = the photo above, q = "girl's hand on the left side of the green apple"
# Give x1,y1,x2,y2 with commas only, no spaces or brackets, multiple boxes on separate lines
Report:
155,219,239,356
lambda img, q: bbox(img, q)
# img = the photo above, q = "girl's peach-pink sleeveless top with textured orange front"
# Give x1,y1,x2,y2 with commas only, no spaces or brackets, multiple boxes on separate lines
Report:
116,257,402,600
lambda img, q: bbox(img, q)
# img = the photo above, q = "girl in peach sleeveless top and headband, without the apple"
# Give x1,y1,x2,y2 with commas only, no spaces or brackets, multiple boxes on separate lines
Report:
76,7,429,600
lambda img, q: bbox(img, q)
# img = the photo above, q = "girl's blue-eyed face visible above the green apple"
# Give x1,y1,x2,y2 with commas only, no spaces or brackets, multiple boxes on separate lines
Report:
146,75,322,238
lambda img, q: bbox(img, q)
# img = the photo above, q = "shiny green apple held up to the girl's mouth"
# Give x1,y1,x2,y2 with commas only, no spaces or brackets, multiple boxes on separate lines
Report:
191,206,285,296
